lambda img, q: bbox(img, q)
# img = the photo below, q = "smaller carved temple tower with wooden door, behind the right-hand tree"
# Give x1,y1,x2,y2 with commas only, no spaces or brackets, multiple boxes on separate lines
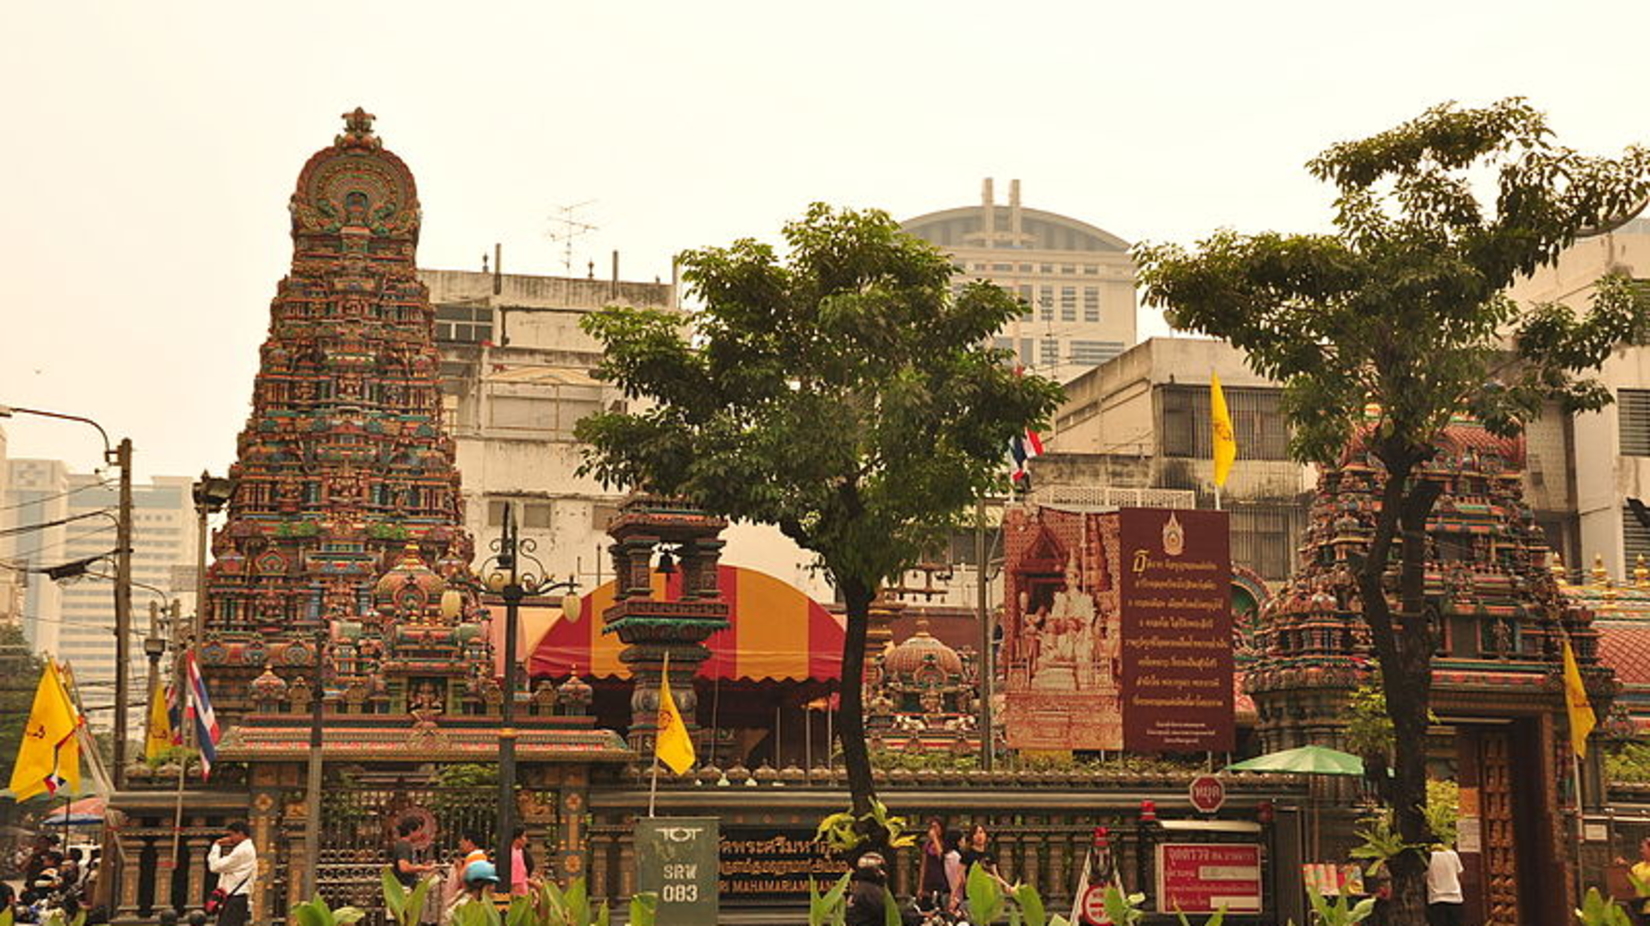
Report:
1246,419,1615,926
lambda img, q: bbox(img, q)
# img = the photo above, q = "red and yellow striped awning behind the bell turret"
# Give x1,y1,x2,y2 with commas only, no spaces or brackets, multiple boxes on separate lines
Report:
528,566,843,682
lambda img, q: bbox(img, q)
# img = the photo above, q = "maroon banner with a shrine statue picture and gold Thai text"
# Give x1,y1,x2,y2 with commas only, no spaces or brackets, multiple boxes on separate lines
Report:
998,507,1233,753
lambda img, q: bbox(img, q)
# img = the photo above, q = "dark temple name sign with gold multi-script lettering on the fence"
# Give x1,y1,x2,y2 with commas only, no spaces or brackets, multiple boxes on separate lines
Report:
719,827,848,897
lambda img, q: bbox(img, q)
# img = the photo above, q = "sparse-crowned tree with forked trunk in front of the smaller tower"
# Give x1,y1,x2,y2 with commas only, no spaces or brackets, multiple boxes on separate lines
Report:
1137,99,1650,924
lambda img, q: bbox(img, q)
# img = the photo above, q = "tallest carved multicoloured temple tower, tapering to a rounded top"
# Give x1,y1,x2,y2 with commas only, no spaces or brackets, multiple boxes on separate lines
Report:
200,109,481,723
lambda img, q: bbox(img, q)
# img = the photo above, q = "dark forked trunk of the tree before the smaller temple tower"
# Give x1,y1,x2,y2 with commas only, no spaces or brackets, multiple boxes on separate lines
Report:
1356,447,1440,926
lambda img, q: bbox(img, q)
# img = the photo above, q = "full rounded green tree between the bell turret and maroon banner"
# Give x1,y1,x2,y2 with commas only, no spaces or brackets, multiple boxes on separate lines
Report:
578,205,1061,840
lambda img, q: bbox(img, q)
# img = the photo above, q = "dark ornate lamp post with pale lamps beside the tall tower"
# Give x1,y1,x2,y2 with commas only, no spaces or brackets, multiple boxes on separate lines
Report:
441,503,579,891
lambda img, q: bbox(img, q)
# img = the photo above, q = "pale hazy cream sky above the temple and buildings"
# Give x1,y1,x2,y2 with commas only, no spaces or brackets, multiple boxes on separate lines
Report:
0,0,1650,477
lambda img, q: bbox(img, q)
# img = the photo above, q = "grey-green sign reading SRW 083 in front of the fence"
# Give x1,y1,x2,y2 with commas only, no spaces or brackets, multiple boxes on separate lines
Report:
635,817,721,926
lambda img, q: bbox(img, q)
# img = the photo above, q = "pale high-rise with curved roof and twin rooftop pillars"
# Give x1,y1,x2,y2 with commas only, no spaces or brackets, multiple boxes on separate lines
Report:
901,180,1137,383
